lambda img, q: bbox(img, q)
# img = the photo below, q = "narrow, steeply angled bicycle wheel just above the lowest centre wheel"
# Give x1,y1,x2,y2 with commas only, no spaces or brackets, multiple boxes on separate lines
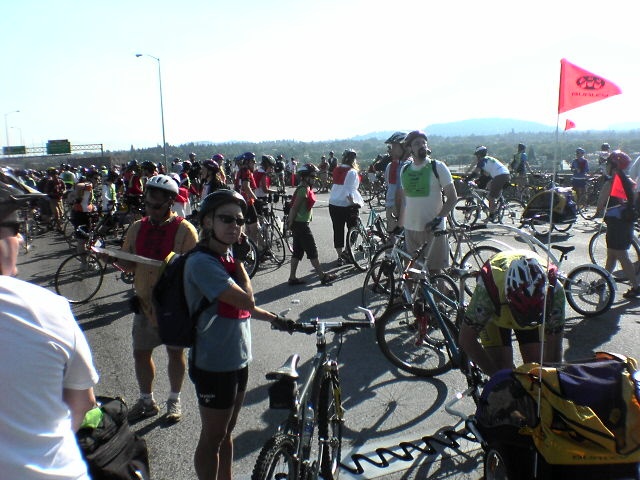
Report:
361,251,396,318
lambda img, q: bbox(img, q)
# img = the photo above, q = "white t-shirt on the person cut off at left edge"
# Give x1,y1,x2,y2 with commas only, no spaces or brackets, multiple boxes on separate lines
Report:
0,275,98,480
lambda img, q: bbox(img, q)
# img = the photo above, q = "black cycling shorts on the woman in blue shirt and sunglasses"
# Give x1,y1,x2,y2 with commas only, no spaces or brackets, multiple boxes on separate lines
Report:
189,365,249,410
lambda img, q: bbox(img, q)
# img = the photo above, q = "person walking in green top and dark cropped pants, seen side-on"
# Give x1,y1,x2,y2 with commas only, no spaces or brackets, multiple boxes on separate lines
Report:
287,163,336,285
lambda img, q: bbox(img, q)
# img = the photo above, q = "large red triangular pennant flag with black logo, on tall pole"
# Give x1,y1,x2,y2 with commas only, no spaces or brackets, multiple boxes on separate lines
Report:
558,58,622,113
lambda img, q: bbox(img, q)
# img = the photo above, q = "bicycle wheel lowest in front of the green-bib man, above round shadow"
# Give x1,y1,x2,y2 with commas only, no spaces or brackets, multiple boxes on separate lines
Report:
376,305,455,377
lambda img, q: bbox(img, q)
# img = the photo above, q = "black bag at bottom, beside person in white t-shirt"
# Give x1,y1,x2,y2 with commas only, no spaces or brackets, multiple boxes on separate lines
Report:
76,397,151,480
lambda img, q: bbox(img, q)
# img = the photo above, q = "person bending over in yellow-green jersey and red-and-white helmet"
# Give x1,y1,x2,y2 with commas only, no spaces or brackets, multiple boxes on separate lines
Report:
459,250,565,375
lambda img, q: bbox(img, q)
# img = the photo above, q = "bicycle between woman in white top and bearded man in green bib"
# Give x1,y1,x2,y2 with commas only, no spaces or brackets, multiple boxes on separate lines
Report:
346,199,389,272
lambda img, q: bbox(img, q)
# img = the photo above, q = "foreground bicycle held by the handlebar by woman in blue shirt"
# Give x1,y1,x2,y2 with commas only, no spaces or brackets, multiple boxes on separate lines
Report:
251,307,375,480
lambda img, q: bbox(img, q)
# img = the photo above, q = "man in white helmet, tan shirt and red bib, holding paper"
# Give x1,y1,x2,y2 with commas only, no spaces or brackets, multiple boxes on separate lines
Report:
117,175,198,422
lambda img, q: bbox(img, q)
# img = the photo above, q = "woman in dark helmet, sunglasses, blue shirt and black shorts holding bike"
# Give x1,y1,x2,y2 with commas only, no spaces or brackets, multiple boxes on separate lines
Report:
184,190,287,479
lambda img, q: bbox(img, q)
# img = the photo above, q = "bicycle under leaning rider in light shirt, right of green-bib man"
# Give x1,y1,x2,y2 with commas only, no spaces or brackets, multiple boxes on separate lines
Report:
451,182,524,230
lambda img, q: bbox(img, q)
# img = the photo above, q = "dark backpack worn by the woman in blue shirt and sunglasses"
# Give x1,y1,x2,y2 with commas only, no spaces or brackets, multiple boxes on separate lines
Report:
152,246,215,348
